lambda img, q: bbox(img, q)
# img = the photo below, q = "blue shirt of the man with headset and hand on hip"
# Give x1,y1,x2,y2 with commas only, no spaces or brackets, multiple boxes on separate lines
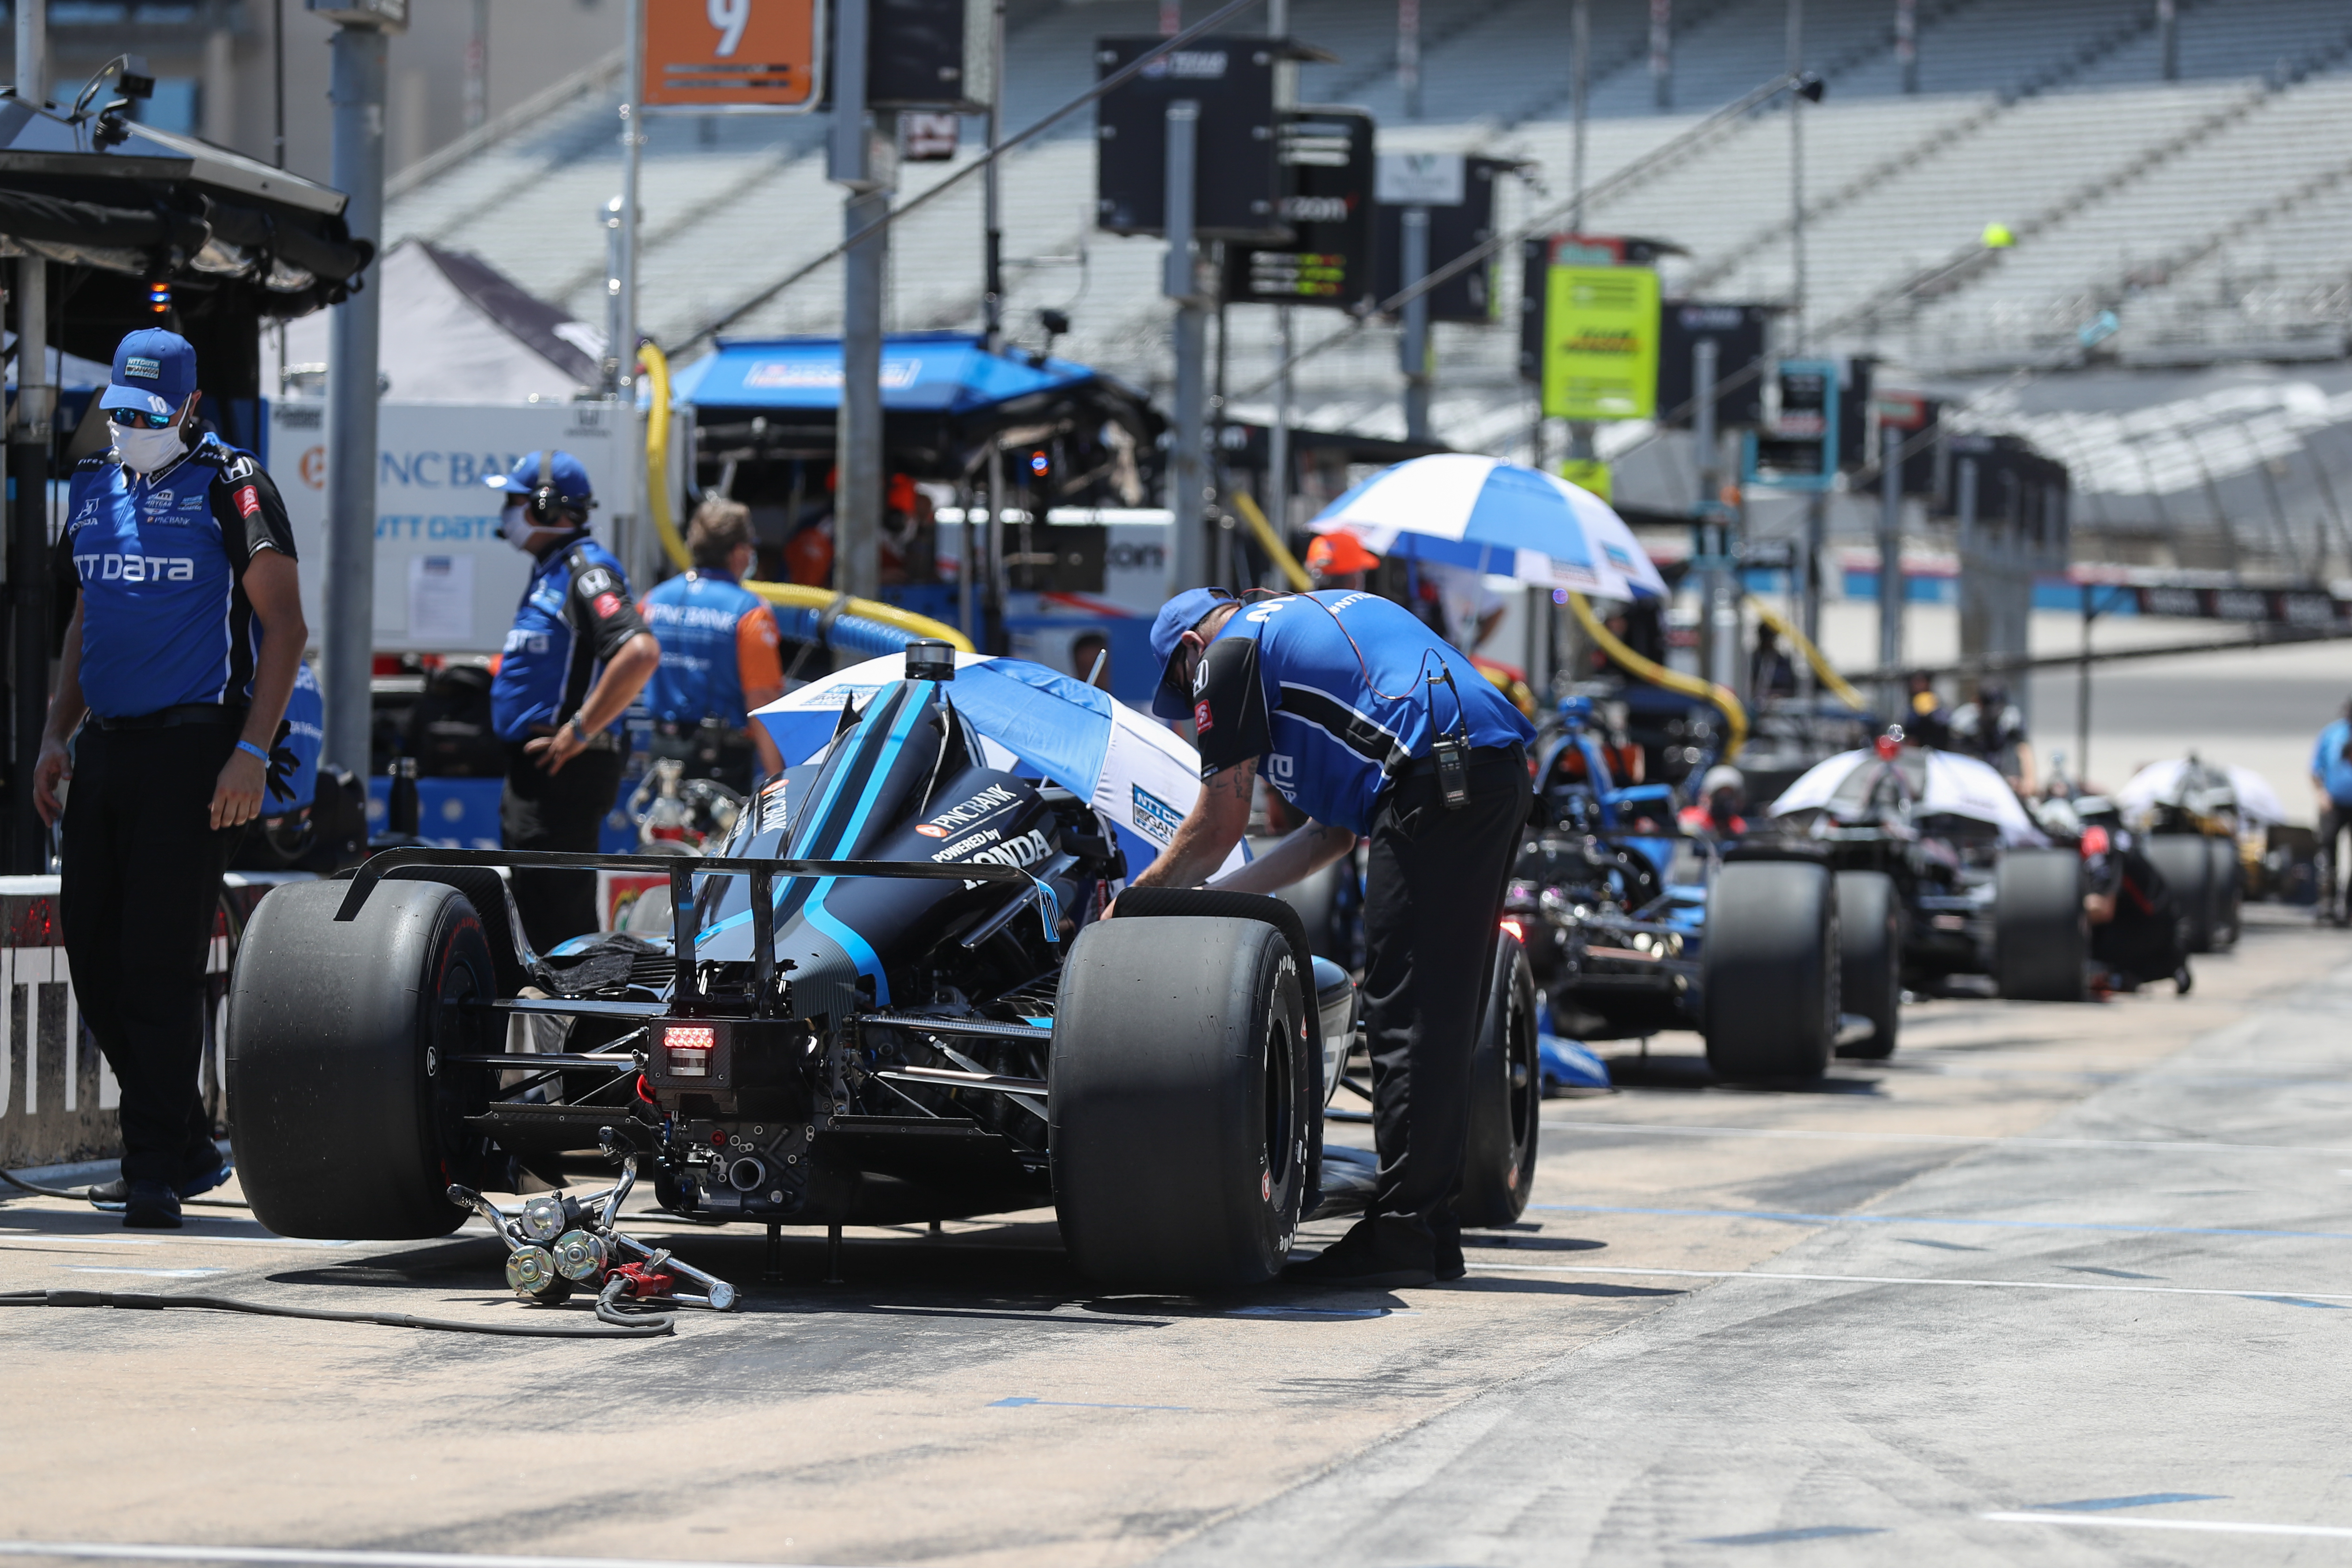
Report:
489,536,644,740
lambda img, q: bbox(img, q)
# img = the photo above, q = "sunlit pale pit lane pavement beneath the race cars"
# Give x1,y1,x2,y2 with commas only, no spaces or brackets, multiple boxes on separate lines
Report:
0,908,2352,1566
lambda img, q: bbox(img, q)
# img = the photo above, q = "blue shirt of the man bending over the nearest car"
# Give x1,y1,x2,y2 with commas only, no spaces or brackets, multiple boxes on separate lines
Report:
1193,590,1536,835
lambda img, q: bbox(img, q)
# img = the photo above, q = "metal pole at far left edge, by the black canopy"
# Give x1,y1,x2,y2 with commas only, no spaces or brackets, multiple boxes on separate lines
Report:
7,0,57,874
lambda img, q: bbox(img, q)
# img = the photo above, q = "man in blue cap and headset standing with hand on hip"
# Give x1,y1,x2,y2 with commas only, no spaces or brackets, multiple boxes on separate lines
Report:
489,451,661,952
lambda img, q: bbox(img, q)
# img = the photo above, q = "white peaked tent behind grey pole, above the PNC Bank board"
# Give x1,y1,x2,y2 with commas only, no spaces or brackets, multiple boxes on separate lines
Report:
261,240,604,402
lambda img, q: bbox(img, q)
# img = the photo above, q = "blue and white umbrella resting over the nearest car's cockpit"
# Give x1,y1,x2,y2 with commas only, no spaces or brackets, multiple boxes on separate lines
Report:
753,653,1249,874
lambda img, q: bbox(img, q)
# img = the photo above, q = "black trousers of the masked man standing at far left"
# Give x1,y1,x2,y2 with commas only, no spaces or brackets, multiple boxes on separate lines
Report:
59,724,244,1182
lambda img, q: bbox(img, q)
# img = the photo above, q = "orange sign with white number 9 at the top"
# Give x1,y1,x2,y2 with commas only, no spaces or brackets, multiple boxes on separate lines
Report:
644,0,823,113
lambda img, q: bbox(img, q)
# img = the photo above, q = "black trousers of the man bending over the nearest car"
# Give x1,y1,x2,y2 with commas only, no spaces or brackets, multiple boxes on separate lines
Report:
1364,748,1531,1251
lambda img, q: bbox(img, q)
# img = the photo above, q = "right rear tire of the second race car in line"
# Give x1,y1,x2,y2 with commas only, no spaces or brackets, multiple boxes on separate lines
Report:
1701,860,1839,1081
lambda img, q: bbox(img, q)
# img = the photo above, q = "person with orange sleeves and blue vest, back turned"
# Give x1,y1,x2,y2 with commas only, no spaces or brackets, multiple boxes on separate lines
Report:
637,496,783,795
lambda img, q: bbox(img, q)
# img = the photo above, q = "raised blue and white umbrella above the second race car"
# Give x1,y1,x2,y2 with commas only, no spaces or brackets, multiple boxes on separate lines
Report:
1310,451,1665,600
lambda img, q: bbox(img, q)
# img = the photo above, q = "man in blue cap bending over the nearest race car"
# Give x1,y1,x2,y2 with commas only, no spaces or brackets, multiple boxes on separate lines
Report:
1131,587,1536,1288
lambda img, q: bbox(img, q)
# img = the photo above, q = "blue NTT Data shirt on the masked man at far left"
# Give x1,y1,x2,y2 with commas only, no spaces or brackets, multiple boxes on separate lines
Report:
57,435,294,719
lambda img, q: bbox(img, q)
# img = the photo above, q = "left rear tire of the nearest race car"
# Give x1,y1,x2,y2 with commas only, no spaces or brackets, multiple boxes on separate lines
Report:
228,881,501,1241
